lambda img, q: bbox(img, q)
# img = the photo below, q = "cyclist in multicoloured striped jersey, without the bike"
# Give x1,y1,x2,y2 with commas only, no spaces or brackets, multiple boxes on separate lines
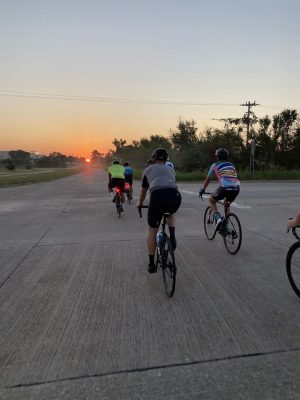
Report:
199,148,240,228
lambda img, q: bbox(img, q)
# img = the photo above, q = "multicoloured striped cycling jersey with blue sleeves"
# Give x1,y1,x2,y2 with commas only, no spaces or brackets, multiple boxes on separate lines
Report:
207,161,240,189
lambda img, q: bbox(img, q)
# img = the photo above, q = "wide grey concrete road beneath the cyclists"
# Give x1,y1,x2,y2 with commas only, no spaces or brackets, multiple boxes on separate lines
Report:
0,170,300,400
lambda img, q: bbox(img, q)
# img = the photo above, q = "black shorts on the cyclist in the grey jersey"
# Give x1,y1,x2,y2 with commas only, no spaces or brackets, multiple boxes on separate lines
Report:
148,188,181,228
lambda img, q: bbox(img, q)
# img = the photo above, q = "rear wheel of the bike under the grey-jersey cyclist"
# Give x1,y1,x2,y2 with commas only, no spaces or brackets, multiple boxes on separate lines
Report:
161,235,176,297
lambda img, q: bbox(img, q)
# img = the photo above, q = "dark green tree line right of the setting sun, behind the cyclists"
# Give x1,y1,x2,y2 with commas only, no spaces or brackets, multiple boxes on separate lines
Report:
91,109,300,172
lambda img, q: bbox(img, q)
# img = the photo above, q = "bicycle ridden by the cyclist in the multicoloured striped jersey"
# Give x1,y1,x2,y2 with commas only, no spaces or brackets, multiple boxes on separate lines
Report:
199,192,242,255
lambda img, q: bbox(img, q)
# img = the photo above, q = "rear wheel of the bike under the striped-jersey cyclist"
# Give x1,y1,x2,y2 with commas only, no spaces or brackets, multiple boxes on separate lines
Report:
223,214,242,254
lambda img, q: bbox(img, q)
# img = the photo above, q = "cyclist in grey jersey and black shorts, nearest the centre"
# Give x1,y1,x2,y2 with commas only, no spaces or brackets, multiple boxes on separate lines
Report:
138,148,181,273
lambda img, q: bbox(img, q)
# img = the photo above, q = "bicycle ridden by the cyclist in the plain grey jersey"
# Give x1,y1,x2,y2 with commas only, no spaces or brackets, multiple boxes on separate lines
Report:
138,206,177,297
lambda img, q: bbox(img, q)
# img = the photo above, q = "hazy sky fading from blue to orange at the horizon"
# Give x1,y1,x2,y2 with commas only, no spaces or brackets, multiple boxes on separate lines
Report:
0,0,300,156
